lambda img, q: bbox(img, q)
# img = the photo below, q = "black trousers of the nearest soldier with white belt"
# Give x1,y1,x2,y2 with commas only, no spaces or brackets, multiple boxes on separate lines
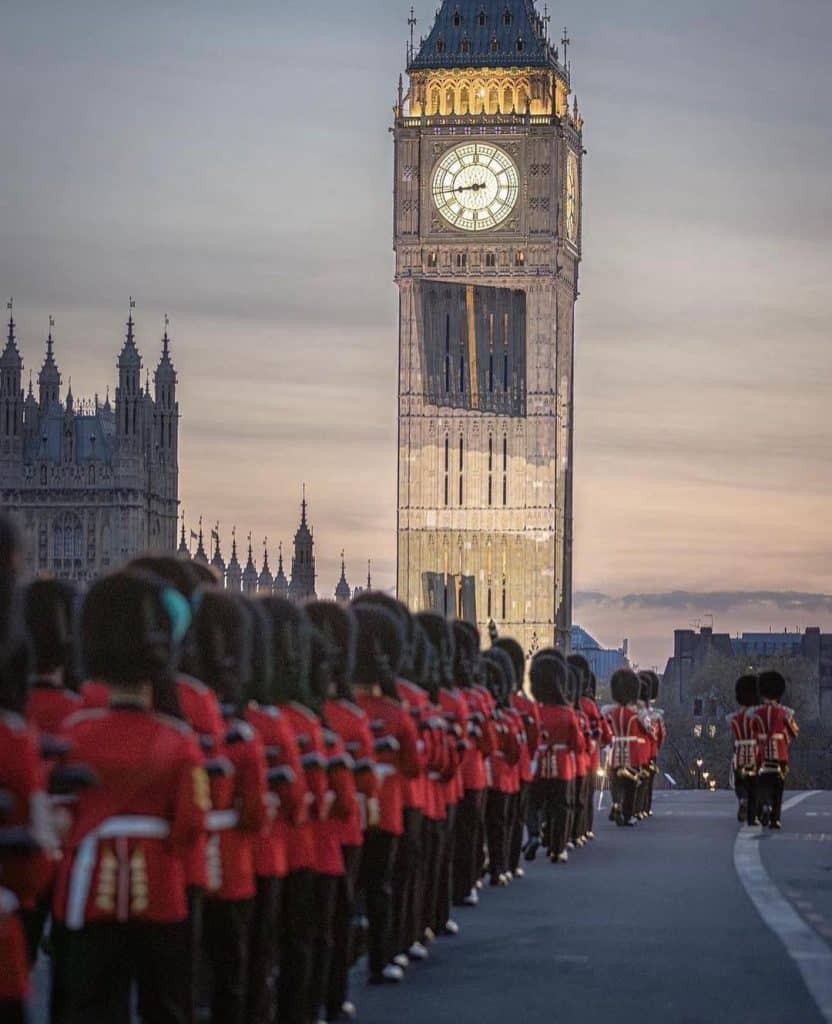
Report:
52,921,191,1024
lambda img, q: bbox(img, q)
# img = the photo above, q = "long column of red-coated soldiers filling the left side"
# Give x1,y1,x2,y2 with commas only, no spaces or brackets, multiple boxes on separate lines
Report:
0,519,663,1024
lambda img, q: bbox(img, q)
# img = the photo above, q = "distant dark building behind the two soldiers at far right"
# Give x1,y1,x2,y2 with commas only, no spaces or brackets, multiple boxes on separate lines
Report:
663,626,832,722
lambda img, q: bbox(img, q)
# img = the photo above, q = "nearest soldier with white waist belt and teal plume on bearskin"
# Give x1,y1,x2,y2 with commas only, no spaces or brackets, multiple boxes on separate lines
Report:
53,572,209,1024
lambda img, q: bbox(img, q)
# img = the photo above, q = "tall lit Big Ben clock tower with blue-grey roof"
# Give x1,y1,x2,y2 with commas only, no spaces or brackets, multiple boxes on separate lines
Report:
393,0,583,650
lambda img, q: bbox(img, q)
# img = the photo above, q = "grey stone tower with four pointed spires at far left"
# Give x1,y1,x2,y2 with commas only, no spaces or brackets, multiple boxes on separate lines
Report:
0,303,179,581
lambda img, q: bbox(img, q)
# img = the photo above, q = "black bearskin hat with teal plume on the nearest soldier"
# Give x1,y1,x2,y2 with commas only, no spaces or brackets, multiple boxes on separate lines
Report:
81,570,184,688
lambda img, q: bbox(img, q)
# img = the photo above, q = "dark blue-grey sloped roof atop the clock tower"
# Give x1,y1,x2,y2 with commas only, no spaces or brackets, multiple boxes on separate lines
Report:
408,0,563,72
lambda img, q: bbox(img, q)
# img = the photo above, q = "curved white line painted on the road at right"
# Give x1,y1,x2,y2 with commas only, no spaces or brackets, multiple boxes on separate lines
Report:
734,791,832,1024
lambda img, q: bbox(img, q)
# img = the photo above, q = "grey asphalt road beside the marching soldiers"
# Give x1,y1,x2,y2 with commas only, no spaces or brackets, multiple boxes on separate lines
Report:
353,792,832,1024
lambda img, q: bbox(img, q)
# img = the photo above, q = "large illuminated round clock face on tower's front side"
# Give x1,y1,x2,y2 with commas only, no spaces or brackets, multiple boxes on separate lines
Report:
431,142,518,231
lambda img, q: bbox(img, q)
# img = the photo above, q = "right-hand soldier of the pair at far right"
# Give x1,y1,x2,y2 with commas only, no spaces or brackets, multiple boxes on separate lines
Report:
749,671,800,829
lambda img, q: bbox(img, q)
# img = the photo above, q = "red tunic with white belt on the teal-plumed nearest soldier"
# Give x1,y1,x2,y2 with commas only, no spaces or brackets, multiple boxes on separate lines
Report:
54,707,210,930
